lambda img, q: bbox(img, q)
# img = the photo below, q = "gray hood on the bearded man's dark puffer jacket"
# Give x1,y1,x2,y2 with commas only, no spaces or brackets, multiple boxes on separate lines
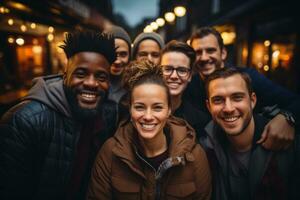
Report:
23,75,72,117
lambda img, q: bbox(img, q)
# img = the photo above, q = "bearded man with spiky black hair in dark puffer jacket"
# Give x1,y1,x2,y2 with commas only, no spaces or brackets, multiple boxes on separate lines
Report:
0,31,116,200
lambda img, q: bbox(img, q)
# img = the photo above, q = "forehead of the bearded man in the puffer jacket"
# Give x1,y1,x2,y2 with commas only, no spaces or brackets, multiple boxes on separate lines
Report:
68,52,110,71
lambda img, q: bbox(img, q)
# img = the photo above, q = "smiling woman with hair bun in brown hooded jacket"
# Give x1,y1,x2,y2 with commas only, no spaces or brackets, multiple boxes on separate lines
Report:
87,61,211,200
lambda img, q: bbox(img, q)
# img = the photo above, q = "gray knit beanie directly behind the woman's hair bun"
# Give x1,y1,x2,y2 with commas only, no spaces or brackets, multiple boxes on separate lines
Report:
132,32,165,59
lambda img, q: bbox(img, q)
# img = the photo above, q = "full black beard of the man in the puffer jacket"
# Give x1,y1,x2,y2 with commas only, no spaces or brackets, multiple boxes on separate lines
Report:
64,86,107,121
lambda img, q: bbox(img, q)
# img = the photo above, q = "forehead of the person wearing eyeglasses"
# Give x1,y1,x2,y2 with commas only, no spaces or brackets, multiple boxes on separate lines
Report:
161,51,190,68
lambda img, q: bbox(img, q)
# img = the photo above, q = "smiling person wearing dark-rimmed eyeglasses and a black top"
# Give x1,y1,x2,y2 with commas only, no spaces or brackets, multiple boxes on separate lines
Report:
160,40,210,138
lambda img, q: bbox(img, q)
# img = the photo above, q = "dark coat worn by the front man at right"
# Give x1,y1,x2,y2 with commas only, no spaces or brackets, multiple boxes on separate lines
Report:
201,116,300,200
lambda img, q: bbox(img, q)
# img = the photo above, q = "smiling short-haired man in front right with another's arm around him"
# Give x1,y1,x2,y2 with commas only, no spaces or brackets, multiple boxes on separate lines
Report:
201,68,300,200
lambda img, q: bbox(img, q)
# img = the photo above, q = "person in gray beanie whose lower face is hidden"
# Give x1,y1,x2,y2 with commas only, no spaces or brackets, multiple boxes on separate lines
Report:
132,32,165,64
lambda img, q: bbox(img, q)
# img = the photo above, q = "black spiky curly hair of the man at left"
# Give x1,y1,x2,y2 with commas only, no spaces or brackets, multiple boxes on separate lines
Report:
59,31,116,64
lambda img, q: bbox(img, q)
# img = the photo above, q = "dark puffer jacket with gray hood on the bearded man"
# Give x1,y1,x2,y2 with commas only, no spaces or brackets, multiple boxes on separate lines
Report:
0,76,116,199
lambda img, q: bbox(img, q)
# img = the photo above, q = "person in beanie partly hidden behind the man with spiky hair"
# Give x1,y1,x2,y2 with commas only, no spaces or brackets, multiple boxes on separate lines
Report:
105,26,131,103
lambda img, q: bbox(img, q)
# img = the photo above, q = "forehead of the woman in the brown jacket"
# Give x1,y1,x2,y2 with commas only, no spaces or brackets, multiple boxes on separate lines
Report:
131,83,167,103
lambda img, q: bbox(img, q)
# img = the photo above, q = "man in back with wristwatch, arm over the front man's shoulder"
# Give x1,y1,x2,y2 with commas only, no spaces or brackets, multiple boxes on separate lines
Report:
185,27,300,150
